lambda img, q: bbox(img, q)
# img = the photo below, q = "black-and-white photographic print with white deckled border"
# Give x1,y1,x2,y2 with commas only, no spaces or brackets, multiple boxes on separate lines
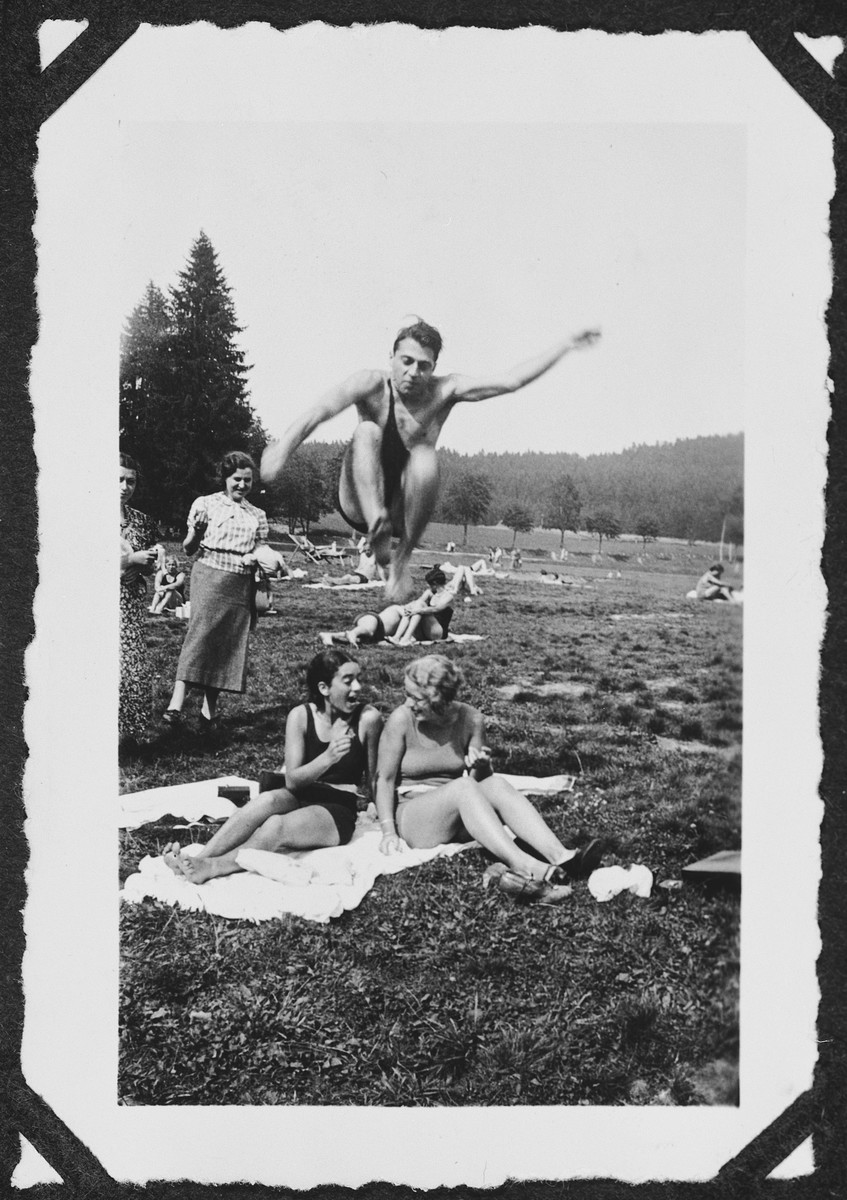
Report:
17,22,841,1188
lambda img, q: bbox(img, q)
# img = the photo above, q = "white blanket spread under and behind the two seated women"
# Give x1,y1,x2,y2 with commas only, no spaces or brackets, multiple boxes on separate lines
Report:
121,775,573,924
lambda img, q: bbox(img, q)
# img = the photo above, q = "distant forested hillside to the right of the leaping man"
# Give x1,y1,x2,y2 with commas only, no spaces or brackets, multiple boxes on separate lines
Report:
435,433,744,541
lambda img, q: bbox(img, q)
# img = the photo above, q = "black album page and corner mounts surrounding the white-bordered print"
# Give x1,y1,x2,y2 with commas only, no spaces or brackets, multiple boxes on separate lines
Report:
0,0,847,1200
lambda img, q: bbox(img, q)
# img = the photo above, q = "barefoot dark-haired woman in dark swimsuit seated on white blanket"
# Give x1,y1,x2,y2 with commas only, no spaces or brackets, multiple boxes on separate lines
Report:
164,649,383,883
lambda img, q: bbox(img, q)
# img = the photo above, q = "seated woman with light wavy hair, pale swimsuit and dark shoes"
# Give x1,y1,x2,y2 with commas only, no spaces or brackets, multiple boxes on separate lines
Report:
376,654,602,902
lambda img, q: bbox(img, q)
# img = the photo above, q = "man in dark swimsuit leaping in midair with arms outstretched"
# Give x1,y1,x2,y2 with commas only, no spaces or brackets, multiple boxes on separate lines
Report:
262,319,600,602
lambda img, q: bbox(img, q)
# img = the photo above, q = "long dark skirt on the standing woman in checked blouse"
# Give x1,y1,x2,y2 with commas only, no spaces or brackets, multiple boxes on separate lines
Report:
176,559,253,692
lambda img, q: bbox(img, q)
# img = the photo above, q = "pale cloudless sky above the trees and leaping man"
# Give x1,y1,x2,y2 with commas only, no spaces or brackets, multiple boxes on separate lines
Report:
120,121,745,454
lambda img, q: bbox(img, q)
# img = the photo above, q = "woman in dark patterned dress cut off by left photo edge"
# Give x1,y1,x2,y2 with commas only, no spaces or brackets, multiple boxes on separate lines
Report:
118,454,158,744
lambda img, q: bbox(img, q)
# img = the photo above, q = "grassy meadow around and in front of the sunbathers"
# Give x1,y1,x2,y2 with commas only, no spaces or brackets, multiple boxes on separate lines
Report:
120,540,741,1105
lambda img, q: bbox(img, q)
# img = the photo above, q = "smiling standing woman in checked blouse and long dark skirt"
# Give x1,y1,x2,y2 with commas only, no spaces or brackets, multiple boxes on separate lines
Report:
164,450,268,730
